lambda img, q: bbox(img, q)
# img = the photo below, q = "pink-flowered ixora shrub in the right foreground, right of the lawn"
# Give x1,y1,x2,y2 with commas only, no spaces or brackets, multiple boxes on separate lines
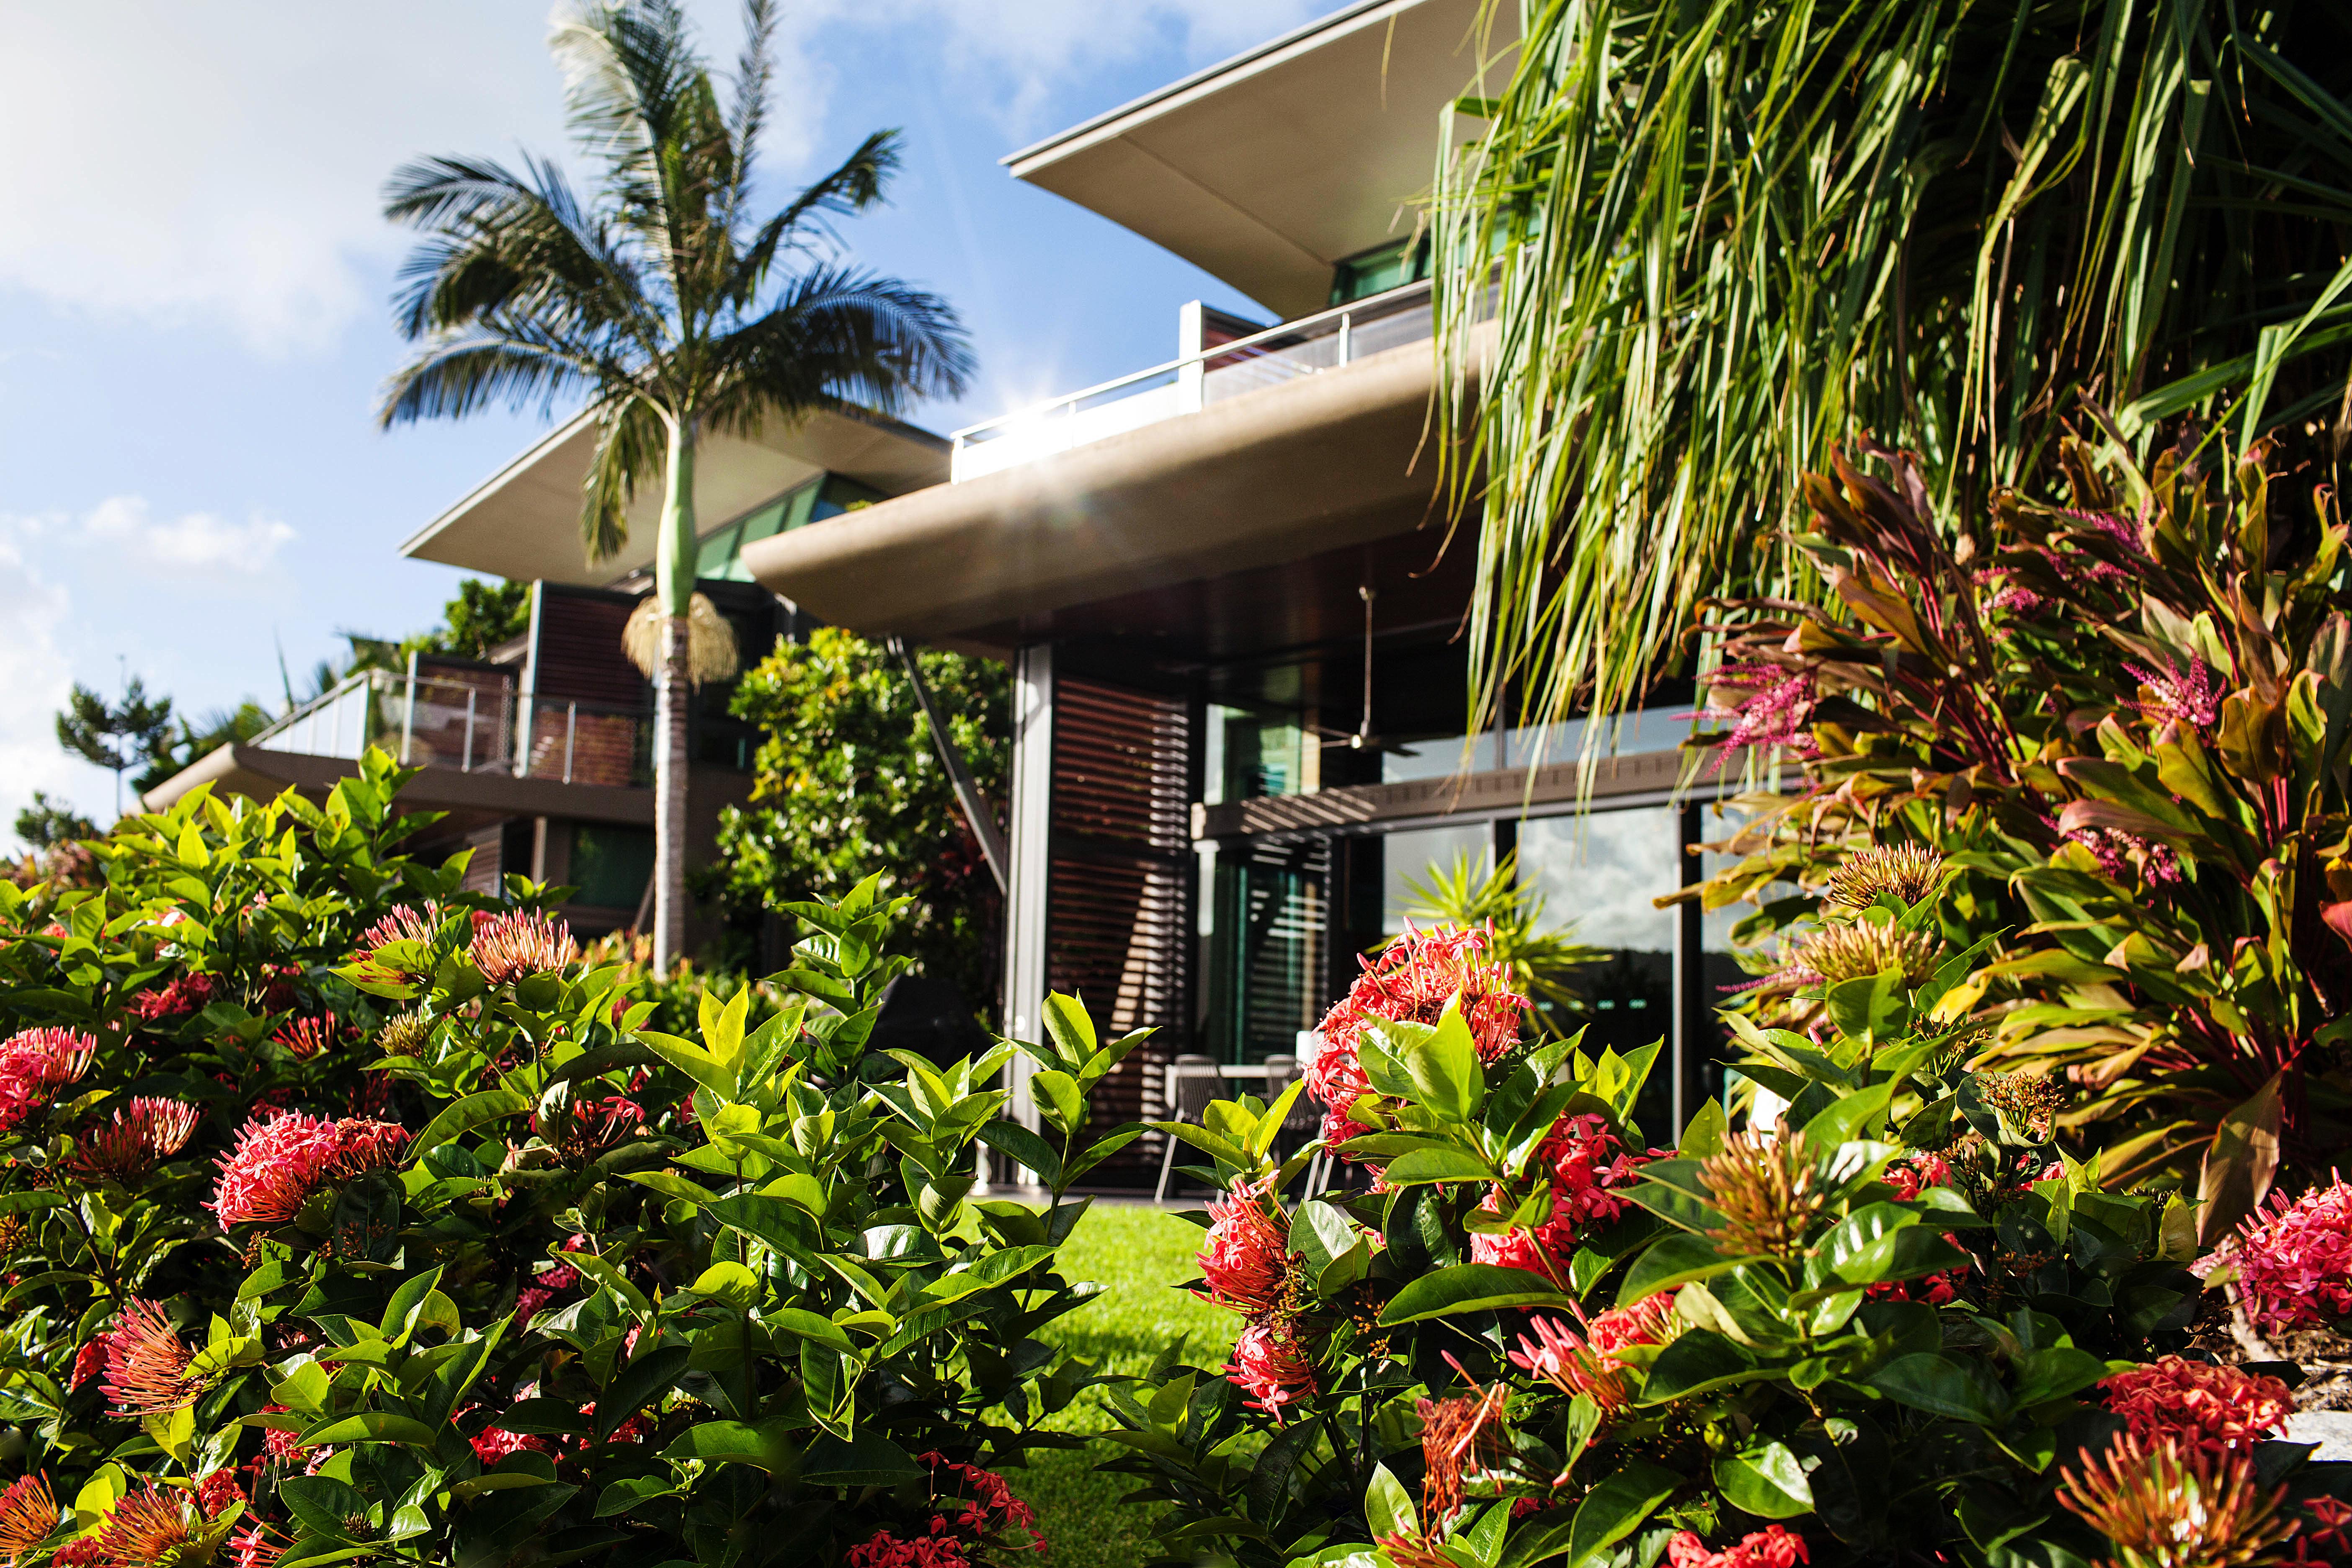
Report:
1110,907,2352,1568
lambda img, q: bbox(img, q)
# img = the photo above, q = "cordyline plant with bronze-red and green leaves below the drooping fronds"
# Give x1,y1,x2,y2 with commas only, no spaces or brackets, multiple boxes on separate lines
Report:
1694,423,2352,1241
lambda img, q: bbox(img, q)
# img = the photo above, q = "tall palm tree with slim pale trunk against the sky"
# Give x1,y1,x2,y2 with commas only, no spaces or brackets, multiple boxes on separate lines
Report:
381,0,971,971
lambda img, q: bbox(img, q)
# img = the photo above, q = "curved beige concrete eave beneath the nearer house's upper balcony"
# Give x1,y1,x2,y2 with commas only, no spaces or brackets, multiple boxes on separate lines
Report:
743,329,1491,642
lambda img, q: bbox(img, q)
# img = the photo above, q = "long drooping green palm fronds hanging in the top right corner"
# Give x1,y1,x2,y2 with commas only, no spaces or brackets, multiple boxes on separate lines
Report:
1432,0,2352,752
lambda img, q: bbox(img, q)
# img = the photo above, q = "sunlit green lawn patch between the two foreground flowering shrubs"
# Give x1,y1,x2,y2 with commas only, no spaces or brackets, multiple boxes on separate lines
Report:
1004,1204,1240,1568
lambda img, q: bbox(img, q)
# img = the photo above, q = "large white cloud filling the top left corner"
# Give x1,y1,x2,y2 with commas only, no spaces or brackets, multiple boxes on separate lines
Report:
0,0,557,353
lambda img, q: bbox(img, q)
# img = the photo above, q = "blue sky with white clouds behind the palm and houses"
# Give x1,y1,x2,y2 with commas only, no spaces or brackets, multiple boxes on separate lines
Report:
0,0,1329,844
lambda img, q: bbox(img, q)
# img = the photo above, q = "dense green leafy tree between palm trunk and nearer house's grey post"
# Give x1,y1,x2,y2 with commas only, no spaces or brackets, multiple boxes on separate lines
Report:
720,628,1011,1013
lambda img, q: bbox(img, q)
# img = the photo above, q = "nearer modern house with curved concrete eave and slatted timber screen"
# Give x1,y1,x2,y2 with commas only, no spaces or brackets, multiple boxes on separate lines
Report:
743,0,1738,1166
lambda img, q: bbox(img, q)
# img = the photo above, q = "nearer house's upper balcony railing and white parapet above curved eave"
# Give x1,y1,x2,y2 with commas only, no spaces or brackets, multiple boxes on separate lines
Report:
950,282,1432,484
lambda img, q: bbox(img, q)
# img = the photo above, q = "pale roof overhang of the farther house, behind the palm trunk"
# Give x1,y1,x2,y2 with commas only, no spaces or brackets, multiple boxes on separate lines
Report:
400,414,948,588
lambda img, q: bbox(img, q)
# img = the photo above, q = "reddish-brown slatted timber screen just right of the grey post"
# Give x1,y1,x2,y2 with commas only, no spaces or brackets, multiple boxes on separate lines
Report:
1047,677,1192,1176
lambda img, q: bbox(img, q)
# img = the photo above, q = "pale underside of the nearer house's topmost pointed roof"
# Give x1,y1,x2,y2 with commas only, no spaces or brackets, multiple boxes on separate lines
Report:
1004,0,1519,320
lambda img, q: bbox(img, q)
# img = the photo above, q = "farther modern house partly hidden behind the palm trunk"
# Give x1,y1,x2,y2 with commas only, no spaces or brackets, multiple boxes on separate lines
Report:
146,414,950,945
